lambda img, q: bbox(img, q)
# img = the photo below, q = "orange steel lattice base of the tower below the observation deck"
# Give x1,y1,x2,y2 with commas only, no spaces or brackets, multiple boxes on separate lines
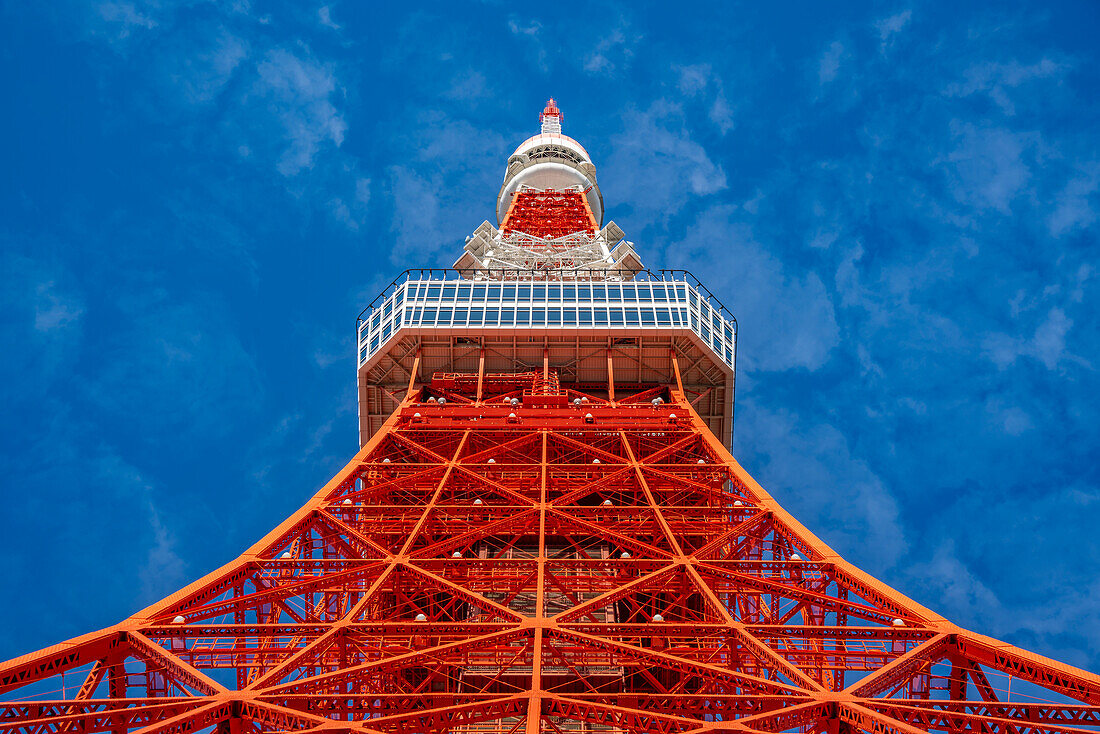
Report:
0,355,1100,734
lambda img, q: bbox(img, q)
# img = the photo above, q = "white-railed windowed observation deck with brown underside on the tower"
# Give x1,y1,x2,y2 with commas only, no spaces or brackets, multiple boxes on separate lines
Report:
356,269,737,446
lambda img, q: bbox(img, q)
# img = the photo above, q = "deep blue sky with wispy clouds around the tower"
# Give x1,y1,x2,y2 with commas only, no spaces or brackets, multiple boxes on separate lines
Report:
0,0,1100,670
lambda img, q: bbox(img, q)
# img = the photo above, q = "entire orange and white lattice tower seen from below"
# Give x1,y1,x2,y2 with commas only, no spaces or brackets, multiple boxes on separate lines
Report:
0,100,1100,734
